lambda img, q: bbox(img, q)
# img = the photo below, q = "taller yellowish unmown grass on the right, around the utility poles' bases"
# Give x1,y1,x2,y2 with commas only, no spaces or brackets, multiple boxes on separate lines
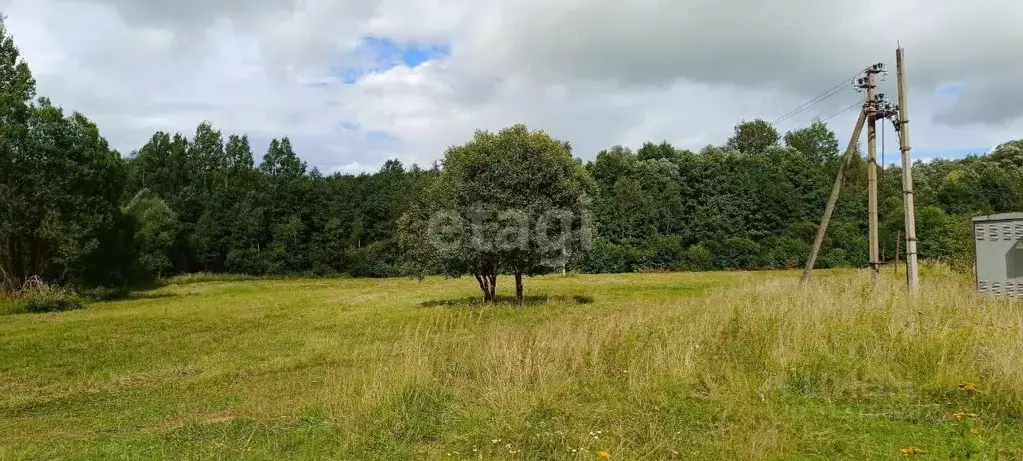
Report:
339,269,1023,459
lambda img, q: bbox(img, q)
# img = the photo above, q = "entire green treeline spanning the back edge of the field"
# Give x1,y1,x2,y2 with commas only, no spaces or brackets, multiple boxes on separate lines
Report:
0,20,1023,289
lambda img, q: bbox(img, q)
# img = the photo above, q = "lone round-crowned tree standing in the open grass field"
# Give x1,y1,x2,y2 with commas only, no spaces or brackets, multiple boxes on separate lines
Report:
398,125,592,306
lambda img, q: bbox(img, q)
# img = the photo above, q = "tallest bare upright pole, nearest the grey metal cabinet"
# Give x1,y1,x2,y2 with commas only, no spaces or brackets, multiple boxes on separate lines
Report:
895,46,920,294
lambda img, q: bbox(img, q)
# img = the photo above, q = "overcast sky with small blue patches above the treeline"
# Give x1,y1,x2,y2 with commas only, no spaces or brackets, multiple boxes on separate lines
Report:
0,0,1023,172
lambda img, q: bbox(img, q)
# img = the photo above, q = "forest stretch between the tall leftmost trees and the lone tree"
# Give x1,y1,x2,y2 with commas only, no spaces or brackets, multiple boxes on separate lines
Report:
126,124,436,276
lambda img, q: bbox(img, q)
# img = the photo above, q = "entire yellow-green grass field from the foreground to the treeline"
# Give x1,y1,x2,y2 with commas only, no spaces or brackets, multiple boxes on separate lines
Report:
0,271,1023,460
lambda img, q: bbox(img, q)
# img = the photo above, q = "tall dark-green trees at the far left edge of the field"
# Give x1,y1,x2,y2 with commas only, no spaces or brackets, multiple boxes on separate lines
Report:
0,22,133,289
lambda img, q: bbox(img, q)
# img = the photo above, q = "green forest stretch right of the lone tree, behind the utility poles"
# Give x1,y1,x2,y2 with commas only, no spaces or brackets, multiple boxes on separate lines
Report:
582,121,1023,272
